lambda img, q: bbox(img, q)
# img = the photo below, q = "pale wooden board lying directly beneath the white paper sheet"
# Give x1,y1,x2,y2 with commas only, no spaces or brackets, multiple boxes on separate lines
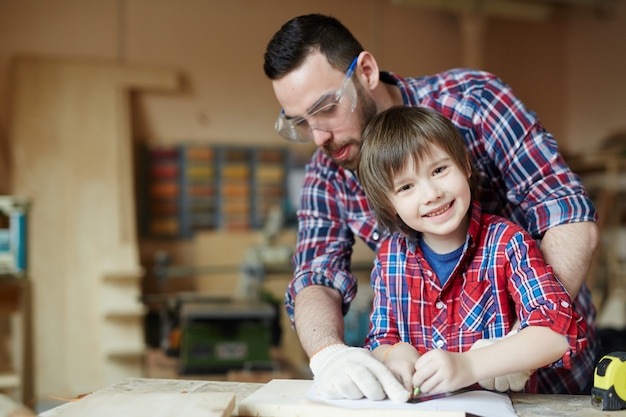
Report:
239,380,466,417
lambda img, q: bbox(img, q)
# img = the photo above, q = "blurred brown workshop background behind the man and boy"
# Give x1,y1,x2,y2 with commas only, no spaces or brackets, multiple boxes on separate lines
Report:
0,0,626,412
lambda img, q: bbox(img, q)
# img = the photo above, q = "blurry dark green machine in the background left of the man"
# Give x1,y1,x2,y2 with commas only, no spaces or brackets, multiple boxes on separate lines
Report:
179,300,276,375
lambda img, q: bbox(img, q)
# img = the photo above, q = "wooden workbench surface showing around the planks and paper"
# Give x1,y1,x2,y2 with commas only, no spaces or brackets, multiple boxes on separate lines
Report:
40,378,626,417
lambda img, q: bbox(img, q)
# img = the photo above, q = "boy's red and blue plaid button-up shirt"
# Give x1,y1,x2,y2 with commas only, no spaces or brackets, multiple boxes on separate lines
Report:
366,203,587,376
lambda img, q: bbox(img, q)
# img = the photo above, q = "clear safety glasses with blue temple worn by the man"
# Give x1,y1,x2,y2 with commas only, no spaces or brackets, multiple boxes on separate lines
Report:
274,56,359,143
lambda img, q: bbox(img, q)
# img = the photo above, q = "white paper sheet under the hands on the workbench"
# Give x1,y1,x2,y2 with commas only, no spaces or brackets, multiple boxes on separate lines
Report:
306,383,517,417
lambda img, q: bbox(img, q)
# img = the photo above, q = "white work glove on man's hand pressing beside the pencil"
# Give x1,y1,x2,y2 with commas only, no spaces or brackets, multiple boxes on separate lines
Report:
310,344,411,402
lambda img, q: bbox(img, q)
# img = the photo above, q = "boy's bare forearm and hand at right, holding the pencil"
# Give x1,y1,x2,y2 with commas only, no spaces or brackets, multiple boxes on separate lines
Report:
413,326,569,394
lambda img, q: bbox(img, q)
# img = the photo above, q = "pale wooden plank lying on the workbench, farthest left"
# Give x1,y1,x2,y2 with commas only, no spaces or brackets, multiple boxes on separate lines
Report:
53,392,235,417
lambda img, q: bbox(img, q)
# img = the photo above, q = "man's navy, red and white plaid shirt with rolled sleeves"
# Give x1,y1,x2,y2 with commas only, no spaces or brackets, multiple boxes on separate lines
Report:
285,69,599,393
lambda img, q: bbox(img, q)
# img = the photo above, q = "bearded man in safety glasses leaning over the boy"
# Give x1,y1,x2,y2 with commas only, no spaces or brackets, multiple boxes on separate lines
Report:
264,14,600,401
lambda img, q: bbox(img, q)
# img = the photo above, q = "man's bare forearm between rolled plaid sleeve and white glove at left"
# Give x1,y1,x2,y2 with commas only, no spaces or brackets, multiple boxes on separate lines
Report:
294,285,344,357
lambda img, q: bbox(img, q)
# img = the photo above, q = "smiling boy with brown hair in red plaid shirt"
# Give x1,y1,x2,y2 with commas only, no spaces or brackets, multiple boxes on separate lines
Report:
358,107,586,393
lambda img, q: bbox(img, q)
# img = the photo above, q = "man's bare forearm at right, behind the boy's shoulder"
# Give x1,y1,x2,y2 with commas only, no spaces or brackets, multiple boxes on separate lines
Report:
541,222,599,300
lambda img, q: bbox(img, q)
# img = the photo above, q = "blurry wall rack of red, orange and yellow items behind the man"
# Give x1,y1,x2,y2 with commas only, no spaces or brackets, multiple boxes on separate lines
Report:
142,144,294,238
